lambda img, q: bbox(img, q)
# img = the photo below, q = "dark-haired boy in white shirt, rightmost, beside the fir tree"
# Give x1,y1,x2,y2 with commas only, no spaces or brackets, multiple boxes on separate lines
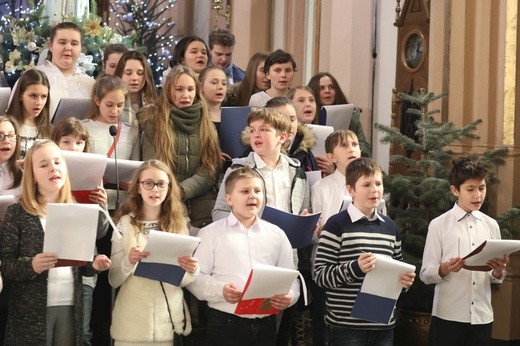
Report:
420,156,509,346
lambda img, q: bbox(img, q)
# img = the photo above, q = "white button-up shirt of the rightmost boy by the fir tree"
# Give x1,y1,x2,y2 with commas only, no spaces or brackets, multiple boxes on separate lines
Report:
420,204,505,324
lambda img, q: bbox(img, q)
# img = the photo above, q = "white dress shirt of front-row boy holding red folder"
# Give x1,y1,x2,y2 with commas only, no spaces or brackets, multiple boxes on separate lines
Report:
188,213,300,318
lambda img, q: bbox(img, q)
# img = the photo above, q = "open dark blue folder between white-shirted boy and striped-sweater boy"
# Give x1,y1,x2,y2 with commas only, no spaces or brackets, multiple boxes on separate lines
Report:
262,206,321,249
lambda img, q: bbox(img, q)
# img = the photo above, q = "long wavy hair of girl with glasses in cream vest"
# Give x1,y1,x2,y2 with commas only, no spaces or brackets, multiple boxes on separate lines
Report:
117,160,188,233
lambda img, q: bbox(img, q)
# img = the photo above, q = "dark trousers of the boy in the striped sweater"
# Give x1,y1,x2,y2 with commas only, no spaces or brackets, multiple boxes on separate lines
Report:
328,326,394,346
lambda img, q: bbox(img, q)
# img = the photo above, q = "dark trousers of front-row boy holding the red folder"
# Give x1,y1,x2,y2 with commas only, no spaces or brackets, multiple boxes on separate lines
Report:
206,308,276,346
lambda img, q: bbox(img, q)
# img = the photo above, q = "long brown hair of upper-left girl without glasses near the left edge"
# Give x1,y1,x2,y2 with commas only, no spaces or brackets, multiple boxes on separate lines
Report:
6,69,52,138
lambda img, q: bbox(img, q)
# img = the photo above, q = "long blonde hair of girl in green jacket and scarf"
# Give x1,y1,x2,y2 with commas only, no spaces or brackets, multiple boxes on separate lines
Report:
139,65,220,178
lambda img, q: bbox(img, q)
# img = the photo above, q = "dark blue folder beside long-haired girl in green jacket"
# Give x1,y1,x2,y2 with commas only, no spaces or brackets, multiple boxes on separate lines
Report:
219,107,251,158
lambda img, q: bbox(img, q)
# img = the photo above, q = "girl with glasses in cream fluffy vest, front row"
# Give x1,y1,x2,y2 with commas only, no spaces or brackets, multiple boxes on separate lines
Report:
108,160,199,345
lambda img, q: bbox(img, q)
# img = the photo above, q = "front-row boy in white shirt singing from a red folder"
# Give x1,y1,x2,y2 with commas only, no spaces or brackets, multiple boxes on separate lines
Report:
188,166,300,346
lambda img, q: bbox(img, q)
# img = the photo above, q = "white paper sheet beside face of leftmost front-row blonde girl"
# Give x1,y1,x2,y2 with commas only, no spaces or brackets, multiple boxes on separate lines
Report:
62,150,107,190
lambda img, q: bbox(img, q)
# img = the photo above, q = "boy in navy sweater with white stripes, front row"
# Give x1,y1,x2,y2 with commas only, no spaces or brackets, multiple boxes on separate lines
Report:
314,158,415,346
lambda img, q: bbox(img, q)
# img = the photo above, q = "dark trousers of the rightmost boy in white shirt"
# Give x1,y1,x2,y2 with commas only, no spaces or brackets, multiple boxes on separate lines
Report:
430,316,492,346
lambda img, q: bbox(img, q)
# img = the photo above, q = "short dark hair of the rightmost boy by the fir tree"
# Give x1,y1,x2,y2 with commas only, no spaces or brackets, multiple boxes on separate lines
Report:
448,155,489,190
